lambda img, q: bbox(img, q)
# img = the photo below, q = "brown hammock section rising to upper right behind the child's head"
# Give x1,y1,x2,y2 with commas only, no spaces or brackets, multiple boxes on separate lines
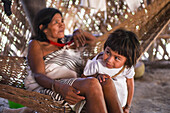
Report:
81,0,170,60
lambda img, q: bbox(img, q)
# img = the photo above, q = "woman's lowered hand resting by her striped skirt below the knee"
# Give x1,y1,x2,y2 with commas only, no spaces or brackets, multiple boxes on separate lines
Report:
56,84,85,105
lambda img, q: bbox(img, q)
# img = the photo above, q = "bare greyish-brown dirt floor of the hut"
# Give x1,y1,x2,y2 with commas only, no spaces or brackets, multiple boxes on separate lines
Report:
0,61,170,113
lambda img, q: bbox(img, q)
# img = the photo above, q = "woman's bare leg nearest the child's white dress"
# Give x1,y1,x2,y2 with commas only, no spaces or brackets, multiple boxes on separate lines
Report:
101,79,123,113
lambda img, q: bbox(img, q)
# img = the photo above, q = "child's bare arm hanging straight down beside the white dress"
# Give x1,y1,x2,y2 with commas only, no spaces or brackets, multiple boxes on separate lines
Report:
124,78,134,113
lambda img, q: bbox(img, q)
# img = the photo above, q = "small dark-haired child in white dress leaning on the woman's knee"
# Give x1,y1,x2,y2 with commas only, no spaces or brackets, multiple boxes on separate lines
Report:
83,29,140,113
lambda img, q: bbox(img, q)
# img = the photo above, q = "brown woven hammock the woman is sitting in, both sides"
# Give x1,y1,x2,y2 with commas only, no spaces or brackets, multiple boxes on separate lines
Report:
0,0,170,113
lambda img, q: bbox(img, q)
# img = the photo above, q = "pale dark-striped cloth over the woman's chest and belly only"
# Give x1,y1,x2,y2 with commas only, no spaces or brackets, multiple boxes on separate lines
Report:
45,49,82,79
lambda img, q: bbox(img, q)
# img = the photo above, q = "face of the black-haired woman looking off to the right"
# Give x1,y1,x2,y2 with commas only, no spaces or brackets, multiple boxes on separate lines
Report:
44,13,65,41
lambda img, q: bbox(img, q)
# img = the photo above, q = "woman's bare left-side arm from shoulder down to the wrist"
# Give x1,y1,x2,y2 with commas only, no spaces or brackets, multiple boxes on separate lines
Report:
28,40,52,88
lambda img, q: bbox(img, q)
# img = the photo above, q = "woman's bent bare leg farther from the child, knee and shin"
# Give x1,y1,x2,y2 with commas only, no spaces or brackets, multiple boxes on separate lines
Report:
73,77,107,113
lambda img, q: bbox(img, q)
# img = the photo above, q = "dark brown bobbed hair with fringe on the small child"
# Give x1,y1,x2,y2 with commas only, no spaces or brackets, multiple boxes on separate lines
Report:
104,29,140,68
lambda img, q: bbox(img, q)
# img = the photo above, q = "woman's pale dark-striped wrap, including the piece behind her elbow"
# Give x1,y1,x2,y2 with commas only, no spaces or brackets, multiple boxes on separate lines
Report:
25,49,83,91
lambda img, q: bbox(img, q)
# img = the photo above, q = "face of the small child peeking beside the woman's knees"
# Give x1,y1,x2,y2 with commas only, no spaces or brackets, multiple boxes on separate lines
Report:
103,46,126,68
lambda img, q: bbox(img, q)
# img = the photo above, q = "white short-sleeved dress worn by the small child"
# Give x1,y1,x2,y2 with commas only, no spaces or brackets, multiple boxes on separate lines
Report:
83,52,135,107
